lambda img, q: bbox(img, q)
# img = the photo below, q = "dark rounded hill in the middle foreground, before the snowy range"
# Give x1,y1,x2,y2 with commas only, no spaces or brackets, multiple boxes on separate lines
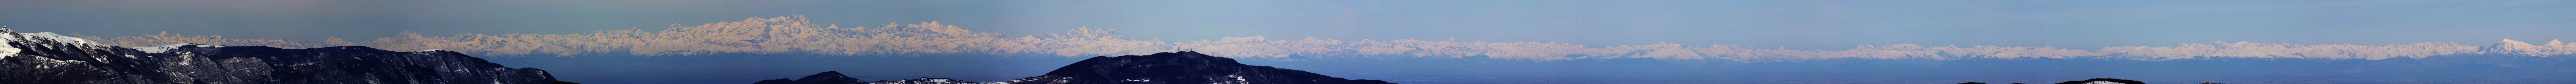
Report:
755,51,1388,84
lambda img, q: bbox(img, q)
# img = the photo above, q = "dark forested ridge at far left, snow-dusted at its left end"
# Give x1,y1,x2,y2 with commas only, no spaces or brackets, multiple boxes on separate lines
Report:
0,28,562,84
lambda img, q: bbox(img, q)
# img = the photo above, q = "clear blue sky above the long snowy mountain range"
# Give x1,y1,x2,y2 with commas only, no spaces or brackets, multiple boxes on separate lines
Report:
0,0,2576,51
